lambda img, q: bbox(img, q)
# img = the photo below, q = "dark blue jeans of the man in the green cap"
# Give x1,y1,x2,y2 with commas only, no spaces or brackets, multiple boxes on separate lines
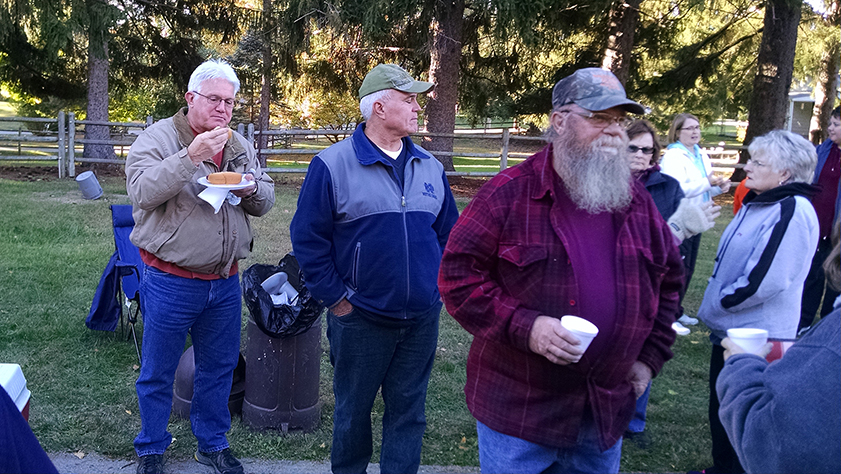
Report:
327,304,441,474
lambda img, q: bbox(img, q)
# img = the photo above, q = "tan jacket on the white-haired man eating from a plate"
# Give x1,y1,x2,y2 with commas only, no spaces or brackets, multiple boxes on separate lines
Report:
126,108,275,278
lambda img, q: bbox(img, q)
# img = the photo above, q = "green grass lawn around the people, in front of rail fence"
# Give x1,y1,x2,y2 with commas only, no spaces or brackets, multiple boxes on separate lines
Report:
0,172,731,472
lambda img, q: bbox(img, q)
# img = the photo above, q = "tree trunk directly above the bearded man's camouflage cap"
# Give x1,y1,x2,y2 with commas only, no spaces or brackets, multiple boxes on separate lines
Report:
602,0,642,85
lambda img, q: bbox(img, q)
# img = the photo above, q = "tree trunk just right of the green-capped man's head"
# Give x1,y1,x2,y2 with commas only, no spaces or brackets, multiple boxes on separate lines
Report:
424,0,464,171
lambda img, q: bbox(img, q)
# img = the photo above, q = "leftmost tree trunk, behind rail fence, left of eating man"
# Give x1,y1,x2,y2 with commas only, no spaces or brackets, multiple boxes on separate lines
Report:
83,36,117,159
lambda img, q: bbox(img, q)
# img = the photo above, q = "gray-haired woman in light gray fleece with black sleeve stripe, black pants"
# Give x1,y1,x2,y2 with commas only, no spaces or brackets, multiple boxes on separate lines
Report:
698,130,818,474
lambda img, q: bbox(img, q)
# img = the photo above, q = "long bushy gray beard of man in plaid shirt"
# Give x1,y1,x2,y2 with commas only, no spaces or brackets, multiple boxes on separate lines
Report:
554,130,631,214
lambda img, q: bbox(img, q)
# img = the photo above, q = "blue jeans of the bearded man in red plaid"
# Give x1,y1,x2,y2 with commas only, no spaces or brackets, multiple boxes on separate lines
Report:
476,410,622,474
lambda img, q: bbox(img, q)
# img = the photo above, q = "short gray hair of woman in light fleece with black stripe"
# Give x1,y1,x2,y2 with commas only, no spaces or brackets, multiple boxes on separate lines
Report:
748,130,818,184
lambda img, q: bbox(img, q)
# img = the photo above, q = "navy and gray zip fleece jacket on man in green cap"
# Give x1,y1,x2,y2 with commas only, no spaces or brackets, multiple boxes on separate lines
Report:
289,123,458,319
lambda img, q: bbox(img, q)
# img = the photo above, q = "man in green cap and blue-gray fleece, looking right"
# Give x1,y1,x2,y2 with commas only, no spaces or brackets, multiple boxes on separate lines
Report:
290,64,458,473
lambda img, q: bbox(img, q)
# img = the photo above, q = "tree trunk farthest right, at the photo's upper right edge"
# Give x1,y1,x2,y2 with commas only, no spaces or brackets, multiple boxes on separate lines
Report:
809,0,841,145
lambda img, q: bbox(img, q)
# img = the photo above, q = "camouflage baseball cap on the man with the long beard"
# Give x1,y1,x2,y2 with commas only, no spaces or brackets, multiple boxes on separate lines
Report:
552,67,645,114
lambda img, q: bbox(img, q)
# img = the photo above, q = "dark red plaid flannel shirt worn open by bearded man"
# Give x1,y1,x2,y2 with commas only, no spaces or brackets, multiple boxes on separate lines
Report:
438,145,683,449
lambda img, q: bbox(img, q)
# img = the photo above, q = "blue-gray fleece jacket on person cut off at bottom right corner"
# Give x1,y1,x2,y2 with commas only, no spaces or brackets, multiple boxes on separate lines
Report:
716,309,841,474
